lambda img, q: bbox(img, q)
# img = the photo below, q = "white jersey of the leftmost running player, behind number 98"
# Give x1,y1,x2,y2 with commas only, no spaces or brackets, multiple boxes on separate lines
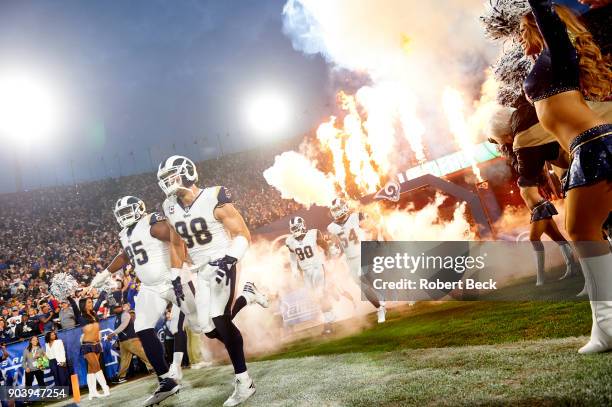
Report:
119,213,171,286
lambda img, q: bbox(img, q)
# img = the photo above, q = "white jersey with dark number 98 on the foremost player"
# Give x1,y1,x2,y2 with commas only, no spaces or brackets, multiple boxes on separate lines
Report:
163,186,232,266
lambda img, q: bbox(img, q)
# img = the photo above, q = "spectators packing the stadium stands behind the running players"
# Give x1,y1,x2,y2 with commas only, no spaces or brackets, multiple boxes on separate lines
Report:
0,140,299,343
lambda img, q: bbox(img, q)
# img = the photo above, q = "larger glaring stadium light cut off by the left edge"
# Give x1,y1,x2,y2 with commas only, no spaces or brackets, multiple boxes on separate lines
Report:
0,71,61,146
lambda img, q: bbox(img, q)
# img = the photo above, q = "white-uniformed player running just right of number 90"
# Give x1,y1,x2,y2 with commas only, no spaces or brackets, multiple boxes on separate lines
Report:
327,198,386,323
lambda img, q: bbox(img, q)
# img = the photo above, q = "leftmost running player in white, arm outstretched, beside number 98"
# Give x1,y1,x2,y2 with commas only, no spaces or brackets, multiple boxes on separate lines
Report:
91,196,198,406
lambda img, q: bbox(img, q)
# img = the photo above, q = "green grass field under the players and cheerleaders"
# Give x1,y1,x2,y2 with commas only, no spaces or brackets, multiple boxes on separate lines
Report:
49,272,612,407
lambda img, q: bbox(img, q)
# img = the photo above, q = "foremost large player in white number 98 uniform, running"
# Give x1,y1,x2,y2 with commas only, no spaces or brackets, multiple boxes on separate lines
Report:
157,155,268,406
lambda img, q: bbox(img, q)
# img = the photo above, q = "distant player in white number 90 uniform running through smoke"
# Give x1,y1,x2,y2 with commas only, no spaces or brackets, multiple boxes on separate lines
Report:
285,216,336,333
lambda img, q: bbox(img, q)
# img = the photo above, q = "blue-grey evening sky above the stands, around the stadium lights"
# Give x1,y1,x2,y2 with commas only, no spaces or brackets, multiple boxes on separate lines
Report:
0,0,329,192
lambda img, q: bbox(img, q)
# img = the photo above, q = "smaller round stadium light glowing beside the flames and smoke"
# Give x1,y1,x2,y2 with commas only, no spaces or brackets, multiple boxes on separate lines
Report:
246,92,291,137
